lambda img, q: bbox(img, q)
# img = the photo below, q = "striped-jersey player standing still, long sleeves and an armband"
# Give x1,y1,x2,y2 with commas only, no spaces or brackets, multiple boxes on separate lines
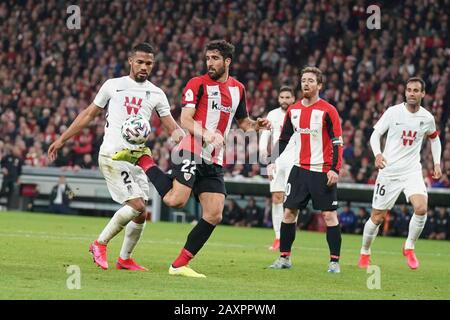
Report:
268,67,342,273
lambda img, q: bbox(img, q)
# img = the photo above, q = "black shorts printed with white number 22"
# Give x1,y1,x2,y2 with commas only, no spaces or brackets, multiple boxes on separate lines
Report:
172,150,227,201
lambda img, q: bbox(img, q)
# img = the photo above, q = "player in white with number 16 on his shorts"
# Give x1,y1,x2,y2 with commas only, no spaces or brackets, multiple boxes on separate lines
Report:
358,77,442,269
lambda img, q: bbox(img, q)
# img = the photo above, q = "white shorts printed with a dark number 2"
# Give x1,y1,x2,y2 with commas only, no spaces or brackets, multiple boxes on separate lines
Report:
98,155,150,204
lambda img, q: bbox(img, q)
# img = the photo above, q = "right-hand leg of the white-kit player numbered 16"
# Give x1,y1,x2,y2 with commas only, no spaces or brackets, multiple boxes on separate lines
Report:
403,173,428,269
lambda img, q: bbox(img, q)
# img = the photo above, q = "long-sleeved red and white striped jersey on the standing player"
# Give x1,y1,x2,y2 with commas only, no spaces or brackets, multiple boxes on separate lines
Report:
279,99,343,173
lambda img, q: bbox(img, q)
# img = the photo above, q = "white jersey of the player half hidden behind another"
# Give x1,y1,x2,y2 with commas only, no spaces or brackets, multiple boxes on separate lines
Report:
259,107,298,167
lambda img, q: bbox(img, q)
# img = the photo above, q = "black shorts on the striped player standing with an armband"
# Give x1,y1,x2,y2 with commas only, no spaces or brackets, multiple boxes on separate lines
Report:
283,166,338,211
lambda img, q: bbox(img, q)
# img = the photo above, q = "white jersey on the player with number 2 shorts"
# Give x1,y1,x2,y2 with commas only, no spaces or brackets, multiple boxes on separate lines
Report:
94,76,170,156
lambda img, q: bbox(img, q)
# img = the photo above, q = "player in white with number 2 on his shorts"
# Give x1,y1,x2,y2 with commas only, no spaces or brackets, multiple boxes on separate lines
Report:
48,43,181,271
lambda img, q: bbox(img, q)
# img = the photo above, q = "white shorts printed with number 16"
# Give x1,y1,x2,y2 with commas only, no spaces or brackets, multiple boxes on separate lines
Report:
372,172,428,210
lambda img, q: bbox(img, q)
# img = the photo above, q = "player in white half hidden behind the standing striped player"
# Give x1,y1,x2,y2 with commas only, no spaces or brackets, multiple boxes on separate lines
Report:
259,86,296,250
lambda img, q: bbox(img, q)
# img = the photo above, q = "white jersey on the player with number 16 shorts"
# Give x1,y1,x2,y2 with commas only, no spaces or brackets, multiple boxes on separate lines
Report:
375,103,437,177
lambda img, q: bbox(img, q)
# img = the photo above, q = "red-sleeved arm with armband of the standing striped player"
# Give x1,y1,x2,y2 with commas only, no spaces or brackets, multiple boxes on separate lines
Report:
325,108,344,186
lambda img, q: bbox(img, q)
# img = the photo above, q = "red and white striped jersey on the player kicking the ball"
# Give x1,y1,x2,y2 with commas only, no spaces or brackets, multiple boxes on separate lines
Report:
179,74,248,165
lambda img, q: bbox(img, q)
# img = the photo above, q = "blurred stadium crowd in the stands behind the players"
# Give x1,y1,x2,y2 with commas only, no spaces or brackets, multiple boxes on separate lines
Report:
0,0,450,187
